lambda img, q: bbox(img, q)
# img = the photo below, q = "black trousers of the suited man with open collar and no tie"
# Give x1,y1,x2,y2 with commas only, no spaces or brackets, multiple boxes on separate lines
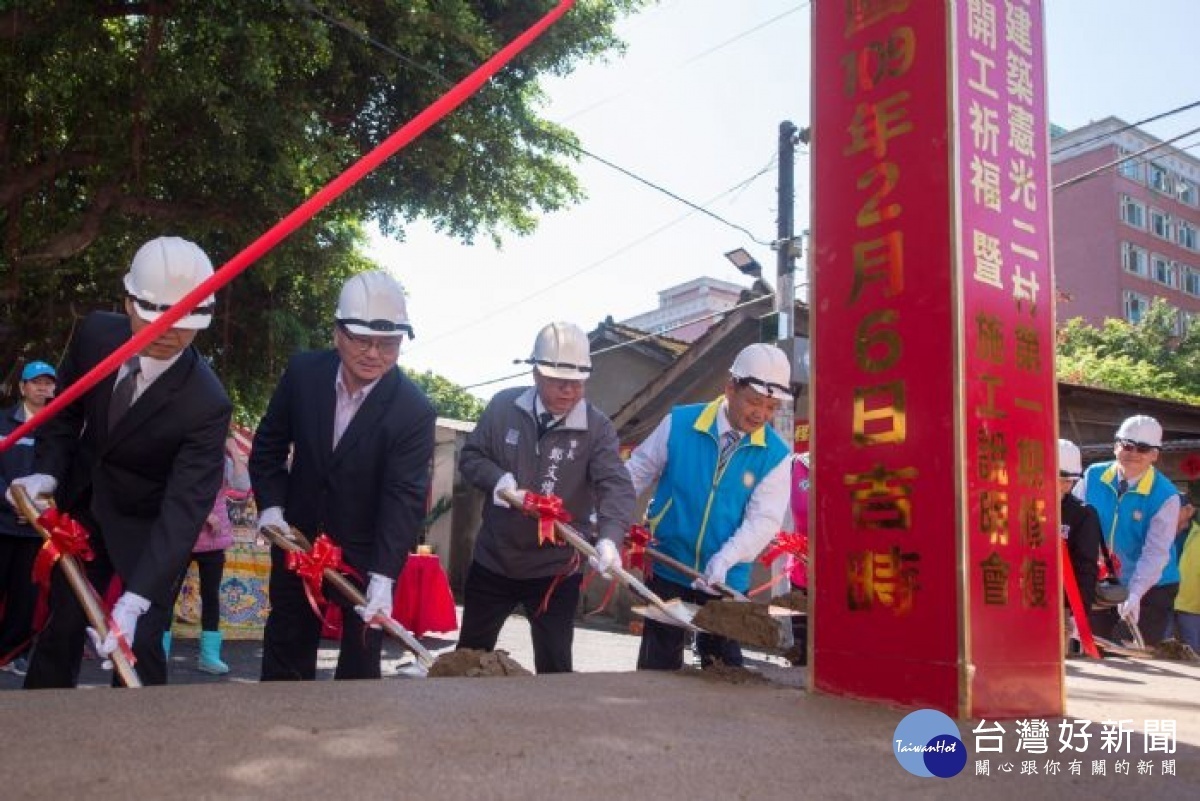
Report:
260,546,383,681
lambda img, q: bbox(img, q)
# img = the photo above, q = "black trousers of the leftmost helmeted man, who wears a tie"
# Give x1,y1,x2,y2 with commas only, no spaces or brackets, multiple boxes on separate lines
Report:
25,541,170,689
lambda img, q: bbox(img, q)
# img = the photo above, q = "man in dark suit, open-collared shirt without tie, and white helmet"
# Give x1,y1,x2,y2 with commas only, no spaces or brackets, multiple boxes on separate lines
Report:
250,271,437,681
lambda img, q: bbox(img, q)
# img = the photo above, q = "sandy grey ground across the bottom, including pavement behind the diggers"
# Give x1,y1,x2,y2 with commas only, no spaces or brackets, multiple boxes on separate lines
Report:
0,618,1200,801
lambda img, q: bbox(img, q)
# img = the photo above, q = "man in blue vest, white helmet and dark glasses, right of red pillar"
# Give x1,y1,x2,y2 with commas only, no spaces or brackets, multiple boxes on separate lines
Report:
1074,415,1180,646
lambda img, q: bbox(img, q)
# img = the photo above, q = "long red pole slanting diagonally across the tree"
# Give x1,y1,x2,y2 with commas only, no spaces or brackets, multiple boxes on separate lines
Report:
0,0,575,452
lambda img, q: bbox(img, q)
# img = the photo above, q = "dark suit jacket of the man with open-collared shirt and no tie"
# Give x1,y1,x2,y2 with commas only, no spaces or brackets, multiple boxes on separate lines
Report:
250,350,437,578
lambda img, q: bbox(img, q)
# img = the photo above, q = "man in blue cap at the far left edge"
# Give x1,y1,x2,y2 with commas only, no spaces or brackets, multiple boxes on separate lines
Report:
0,361,58,676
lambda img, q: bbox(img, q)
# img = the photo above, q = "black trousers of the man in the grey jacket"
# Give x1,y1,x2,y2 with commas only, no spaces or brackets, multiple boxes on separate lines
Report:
457,561,583,673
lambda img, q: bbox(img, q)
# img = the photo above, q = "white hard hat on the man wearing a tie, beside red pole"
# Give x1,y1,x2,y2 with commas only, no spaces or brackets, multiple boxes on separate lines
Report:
125,236,216,329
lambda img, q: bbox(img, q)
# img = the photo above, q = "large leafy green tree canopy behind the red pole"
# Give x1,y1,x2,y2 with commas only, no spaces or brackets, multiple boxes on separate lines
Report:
0,0,643,419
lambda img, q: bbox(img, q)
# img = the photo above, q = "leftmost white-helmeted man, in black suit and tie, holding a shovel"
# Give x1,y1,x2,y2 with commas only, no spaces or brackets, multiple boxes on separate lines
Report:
13,236,233,688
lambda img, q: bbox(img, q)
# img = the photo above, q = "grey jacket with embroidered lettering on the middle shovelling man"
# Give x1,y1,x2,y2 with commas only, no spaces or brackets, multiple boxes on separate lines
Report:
458,387,636,579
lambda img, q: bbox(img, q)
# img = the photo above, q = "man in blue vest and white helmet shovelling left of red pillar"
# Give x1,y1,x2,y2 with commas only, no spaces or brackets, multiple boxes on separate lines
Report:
626,343,794,670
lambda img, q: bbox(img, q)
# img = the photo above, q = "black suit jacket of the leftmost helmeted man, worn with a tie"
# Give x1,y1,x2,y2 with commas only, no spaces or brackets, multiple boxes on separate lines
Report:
34,312,233,604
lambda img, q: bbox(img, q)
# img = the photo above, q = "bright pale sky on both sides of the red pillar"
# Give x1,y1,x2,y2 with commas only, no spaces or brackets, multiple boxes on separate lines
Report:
372,0,1200,397
